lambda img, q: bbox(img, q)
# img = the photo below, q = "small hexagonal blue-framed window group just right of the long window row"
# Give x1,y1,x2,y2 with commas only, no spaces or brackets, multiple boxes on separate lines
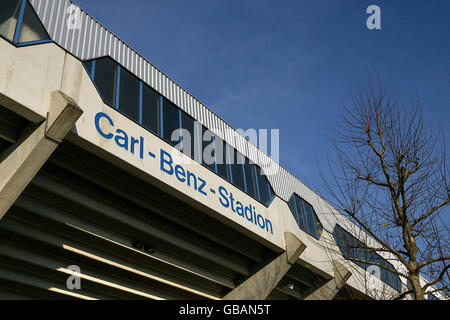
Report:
288,193,323,240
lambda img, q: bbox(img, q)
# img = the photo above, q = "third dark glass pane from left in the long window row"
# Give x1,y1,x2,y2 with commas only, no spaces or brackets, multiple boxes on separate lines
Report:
142,85,160,134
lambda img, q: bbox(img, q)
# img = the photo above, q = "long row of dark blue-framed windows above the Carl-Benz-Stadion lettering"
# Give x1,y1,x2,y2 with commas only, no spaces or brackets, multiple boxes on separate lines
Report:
84,57,275,205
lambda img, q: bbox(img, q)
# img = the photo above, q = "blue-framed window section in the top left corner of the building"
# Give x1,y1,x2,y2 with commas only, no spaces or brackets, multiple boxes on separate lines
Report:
0,0,50,45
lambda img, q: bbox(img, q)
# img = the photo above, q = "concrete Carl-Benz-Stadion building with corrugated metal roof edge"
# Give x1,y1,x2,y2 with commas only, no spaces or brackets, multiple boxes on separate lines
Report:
0,0,439,299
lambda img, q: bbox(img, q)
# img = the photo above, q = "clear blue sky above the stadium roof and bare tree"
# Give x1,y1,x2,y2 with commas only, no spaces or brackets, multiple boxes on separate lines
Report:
75,0,450,196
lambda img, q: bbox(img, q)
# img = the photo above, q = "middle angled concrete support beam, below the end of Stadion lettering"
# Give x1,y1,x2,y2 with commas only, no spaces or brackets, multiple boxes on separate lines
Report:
223,232,306,300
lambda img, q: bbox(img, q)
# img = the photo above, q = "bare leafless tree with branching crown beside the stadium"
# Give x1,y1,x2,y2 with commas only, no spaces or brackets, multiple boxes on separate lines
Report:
322,78,450,300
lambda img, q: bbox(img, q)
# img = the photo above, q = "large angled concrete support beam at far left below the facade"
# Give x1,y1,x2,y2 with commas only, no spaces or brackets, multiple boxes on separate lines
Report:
0,91,83,220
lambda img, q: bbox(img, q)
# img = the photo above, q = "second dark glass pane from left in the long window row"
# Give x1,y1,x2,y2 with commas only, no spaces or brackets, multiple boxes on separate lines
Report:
119,68,139,122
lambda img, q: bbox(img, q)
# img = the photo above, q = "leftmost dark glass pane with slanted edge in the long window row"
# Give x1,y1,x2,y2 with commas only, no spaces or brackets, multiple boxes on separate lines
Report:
94,58,117,107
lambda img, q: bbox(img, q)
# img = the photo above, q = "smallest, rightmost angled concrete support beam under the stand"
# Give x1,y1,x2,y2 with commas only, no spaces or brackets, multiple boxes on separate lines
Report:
304,260,352,300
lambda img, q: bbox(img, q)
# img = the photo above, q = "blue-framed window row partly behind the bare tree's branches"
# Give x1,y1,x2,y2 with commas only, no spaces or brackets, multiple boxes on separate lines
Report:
333,225,402,292
